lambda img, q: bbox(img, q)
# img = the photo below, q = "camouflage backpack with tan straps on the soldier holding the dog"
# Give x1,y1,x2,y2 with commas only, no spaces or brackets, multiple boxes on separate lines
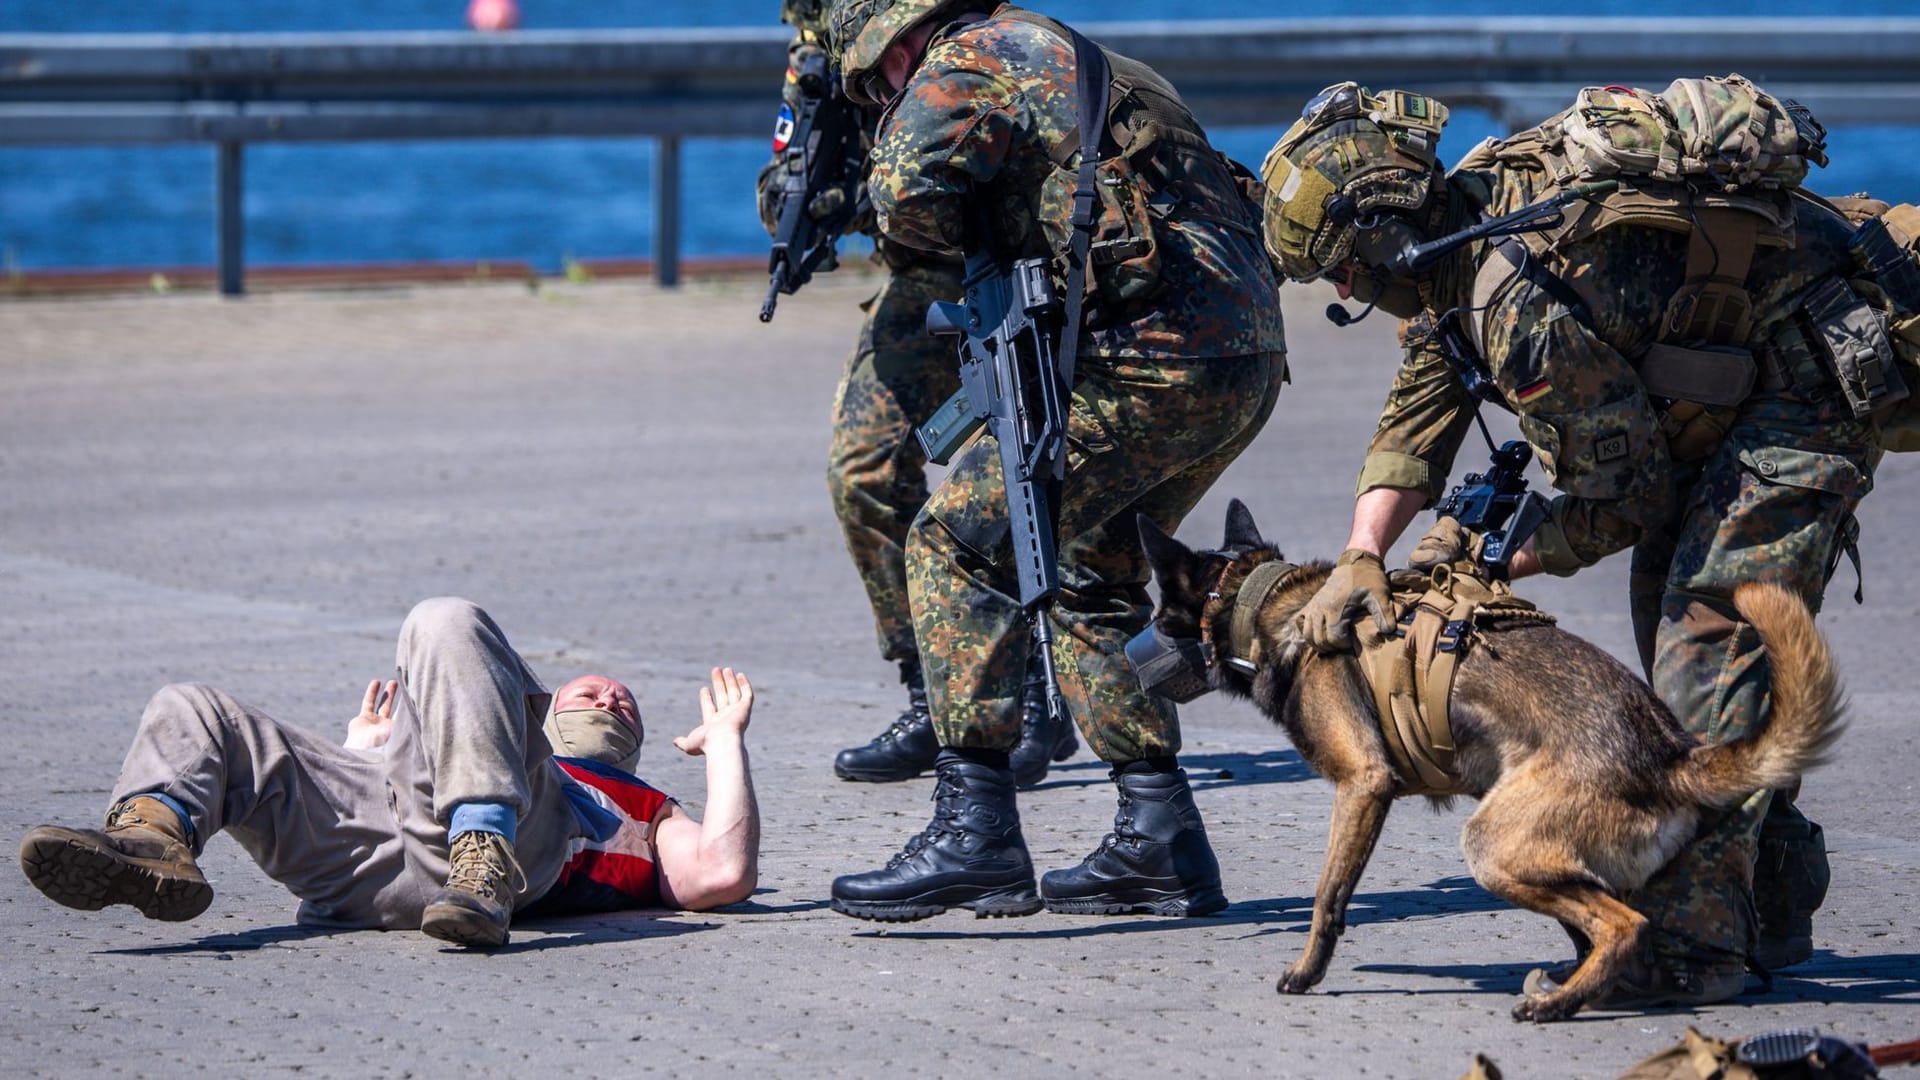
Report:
1459,75,1920,459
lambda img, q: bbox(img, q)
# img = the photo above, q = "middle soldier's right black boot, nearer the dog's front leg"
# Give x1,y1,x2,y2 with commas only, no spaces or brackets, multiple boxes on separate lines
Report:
1041,757,1227,915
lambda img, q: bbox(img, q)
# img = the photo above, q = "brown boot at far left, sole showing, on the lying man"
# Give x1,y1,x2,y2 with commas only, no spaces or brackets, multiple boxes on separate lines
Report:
19,796,213,922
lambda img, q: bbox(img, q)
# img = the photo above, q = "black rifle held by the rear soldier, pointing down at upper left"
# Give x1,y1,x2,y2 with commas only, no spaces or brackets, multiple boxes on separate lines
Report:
760,52,868,323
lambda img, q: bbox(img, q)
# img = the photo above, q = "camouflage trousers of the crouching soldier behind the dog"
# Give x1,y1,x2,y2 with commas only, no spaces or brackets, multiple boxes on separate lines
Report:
1630,380,1878,967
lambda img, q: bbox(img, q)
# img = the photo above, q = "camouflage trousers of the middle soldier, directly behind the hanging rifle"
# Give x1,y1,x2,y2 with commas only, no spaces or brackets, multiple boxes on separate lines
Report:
906,343,1286,761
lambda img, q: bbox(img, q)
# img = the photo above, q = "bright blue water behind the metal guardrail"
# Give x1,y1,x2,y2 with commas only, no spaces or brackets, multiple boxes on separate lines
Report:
0,0,1920,271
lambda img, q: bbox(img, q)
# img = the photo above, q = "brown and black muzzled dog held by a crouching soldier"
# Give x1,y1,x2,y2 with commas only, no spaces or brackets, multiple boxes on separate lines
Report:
1140,500,1841,1020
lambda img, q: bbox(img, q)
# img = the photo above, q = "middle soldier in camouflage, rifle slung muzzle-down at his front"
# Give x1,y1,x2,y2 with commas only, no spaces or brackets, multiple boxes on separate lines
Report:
829,0,1286,920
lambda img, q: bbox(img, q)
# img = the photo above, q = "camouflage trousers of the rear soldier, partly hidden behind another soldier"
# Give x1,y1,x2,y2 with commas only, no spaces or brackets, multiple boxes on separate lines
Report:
828,265,962,661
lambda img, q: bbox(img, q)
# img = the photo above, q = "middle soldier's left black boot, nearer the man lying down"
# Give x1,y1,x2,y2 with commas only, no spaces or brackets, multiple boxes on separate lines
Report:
833,749,1041,922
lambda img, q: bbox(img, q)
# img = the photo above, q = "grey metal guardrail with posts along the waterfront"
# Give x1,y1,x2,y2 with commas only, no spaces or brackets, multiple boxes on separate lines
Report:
0,17,1920,294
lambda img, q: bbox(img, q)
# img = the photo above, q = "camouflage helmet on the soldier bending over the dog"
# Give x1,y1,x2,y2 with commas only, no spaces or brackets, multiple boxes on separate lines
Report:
1260,83,1448,281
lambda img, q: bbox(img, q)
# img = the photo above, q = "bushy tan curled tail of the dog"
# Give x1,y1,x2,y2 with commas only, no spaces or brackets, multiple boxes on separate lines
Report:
1674,582,1845,807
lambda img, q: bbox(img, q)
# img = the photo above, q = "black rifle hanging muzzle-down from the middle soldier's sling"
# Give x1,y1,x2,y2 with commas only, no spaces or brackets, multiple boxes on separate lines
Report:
916,200,1079,723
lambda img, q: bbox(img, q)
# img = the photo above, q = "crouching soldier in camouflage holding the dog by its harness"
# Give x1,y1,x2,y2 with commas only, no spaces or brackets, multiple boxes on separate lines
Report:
1263,83,1878,1007
